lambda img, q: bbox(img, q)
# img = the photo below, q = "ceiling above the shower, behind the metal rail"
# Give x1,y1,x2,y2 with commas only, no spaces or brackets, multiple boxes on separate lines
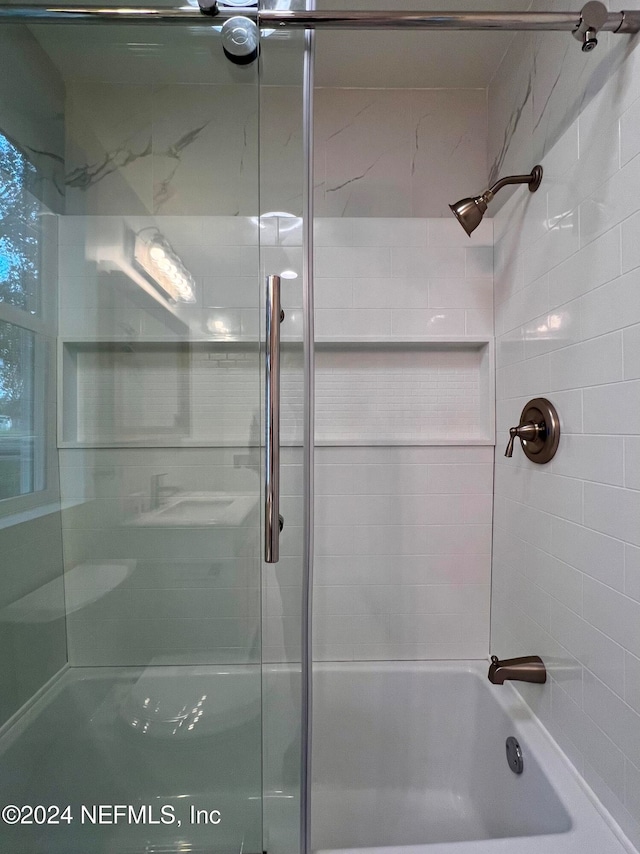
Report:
31,0,530,89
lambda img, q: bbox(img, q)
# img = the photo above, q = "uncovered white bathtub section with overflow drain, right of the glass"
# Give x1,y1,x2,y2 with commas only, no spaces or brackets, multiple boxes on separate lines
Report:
311,662,635,854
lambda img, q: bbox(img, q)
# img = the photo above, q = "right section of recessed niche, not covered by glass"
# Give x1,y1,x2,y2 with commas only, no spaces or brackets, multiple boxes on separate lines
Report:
315,341,493,445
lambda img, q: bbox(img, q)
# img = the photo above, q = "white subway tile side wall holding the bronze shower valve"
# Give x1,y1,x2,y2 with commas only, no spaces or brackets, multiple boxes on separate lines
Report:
492,43,640,846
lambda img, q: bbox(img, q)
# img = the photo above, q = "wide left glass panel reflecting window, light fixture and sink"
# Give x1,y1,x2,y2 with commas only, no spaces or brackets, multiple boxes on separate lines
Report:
0,15,264,854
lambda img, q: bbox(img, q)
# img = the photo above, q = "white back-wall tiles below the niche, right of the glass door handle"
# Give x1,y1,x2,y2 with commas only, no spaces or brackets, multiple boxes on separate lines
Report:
263,445,493,661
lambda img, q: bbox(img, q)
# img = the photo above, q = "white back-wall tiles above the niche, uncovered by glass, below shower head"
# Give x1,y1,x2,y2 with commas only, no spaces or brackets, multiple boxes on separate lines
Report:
315,217,493,340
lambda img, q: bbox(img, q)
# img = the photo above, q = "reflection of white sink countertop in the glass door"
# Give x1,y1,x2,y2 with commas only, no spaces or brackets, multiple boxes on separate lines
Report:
130,492,258,527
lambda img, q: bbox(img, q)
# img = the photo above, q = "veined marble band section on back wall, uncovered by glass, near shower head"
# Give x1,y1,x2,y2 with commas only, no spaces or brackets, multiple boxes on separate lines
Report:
315,89,487,217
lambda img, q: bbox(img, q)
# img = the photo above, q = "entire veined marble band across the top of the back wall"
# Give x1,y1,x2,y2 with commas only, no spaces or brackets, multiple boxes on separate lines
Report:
66,80,487,217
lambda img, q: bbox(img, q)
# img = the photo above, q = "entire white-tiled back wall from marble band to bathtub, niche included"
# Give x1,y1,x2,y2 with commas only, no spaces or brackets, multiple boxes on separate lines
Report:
61,217,493,665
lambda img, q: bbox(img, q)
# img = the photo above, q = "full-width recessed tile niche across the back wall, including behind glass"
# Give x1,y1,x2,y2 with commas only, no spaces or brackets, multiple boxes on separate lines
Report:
59,339,494,447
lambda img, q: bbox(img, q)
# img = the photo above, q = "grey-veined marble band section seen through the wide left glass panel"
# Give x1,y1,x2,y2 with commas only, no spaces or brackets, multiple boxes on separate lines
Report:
66,81,258,216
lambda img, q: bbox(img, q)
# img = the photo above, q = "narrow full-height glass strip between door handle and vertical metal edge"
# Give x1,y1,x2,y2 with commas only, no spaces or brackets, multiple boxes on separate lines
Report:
260,21,311,854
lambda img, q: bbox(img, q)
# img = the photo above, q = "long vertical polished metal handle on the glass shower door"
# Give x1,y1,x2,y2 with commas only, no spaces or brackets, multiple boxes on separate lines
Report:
264,276,284,563
